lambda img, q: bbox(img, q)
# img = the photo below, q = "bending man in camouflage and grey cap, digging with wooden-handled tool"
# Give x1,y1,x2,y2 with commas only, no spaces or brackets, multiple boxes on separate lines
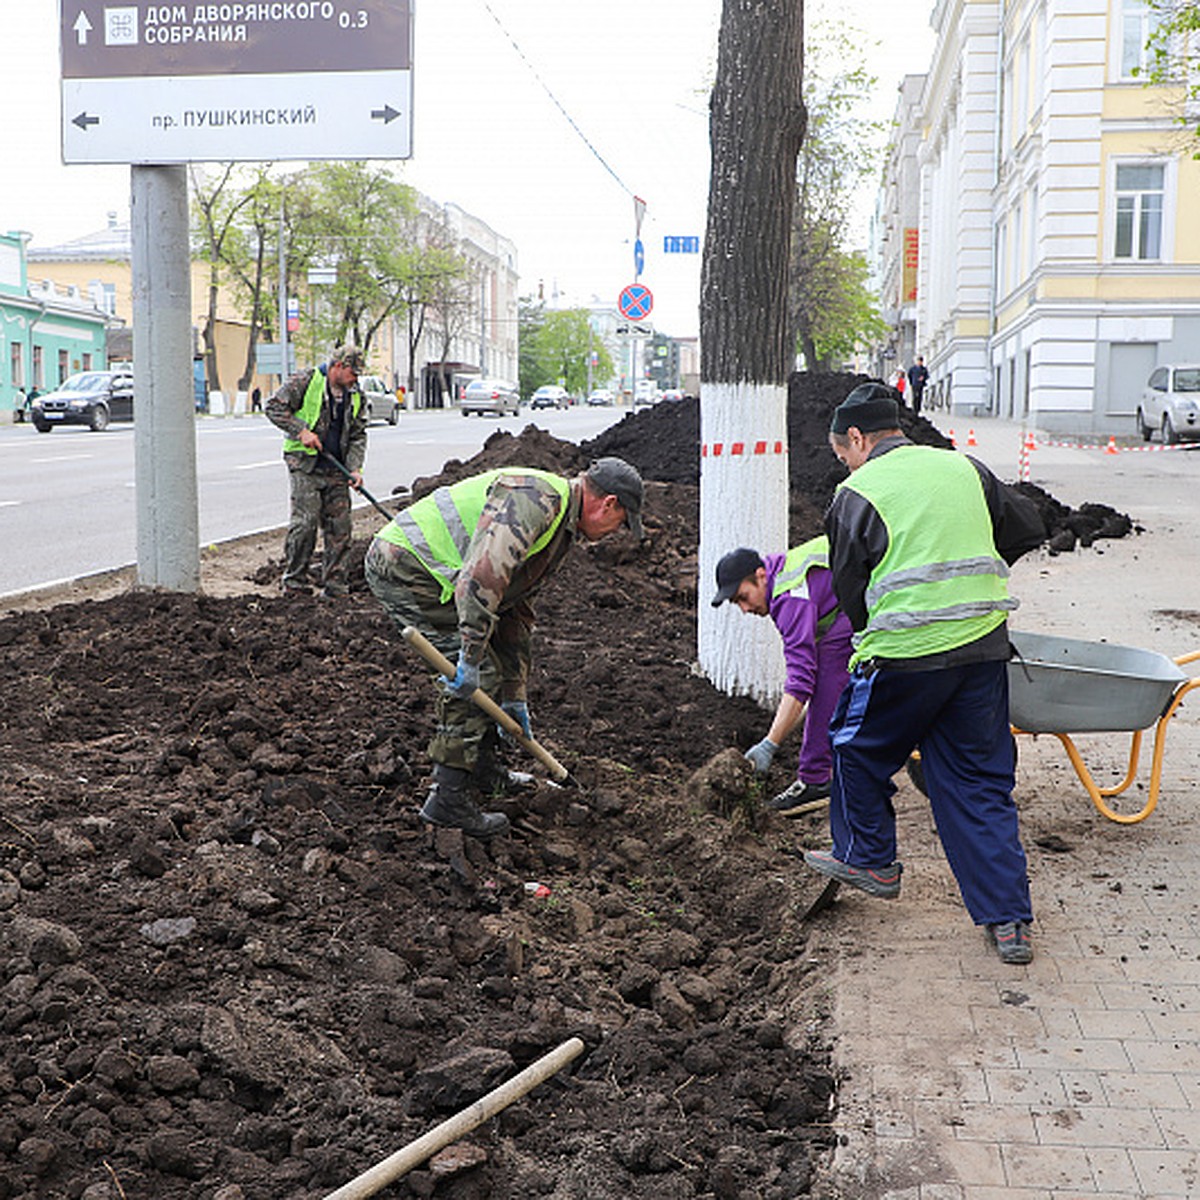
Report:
365,458,642,838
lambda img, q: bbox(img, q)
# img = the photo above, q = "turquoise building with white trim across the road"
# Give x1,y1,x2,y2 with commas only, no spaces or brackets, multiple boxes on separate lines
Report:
0,232,113,421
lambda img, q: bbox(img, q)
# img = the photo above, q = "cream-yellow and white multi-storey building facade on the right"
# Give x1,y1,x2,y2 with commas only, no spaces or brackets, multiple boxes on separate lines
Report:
881,0,1200,433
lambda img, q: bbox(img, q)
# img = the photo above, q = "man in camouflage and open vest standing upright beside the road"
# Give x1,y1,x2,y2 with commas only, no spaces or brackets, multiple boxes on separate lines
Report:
266,346,367,596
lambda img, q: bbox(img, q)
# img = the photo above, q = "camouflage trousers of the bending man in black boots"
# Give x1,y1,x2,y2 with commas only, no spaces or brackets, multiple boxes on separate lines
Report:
364,538,500,772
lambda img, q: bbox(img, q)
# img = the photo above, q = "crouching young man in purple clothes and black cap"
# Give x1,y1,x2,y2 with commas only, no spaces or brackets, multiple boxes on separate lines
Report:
713,535,851,817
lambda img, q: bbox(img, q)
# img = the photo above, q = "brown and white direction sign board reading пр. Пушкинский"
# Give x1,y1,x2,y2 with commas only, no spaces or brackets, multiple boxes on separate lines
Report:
60,0,413,164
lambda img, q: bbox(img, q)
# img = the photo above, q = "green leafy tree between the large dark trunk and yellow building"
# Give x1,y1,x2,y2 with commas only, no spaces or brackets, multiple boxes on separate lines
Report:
788,25,886,371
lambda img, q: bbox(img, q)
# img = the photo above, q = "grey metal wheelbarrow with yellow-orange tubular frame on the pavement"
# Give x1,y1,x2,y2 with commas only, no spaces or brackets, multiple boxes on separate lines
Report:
1008,630,1200,824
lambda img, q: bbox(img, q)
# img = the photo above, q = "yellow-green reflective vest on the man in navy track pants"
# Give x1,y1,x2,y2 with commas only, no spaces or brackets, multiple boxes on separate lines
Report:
838,445,1016,665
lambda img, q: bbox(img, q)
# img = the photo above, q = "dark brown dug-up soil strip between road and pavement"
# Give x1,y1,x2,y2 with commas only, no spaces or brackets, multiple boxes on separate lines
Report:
0,377,1128,1200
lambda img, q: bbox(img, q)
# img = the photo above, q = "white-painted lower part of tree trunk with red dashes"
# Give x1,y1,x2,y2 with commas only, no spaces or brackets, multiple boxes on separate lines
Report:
697,383,788,706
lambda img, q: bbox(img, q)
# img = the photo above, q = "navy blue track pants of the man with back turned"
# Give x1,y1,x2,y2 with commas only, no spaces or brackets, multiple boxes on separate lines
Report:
829,662,1033,925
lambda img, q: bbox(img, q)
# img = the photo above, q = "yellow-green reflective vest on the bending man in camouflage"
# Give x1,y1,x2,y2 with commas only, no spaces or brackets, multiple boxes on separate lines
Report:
377,467,571,604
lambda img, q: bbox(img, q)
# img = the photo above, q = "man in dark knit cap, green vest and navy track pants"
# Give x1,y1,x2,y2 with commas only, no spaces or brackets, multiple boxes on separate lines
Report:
804,383,1045,964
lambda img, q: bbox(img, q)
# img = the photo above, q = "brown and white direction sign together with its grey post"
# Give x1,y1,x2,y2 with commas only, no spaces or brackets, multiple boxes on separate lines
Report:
59,0,413,592
